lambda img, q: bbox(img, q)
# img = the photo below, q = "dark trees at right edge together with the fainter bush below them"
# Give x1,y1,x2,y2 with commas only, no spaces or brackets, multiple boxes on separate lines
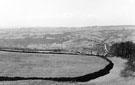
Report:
109,41,135,77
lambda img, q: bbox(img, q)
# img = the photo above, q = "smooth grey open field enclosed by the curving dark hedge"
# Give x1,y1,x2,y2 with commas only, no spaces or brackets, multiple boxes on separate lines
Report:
0,51,108,78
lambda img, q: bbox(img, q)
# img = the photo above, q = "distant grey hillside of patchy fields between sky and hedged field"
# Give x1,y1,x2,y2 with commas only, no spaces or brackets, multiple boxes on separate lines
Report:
0,25,135,52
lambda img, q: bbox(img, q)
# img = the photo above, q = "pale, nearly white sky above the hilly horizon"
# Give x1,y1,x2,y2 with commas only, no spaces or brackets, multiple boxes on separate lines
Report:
0,0,135,28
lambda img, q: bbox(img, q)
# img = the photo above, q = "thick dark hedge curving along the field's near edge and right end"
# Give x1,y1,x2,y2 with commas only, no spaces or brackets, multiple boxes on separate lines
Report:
0,56,114,82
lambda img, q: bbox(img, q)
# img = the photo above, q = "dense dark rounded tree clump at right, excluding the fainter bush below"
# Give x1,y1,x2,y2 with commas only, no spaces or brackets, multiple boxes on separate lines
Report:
110,41,135,58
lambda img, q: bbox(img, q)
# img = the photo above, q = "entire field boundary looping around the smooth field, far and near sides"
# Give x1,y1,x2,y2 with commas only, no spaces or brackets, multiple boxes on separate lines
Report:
0,49,114,82
